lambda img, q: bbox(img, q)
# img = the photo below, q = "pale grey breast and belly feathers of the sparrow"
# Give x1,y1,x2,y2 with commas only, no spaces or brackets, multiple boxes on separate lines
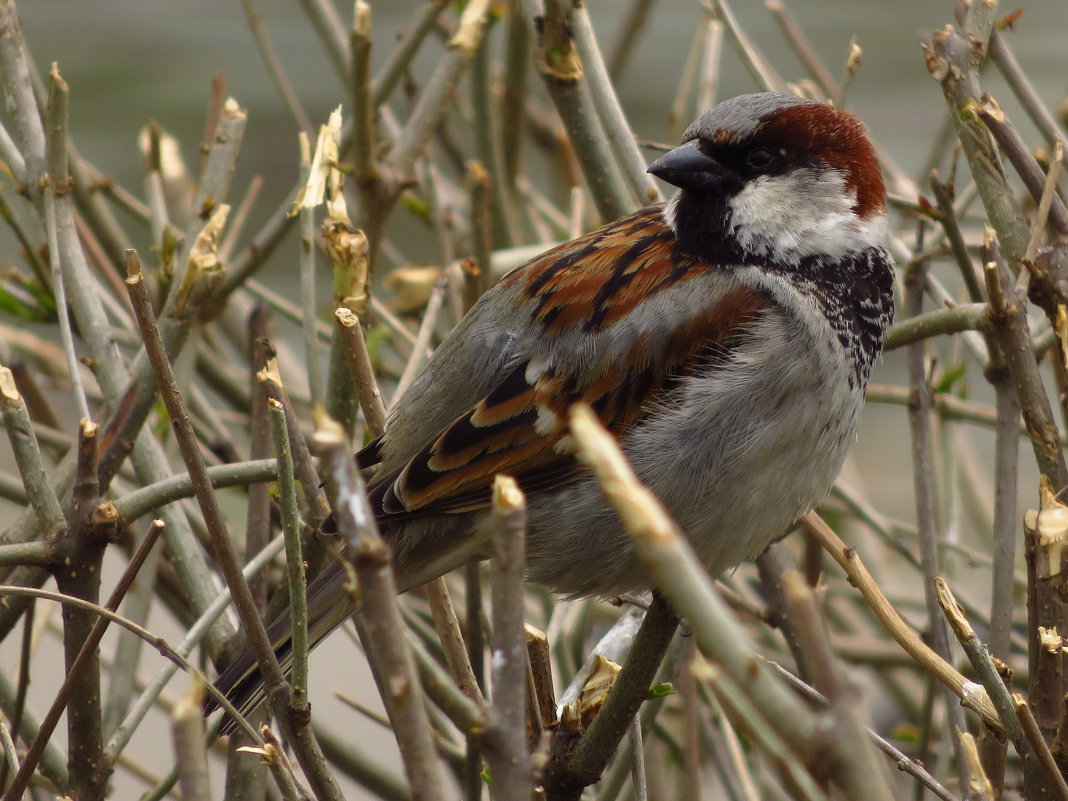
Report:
386,268,863,595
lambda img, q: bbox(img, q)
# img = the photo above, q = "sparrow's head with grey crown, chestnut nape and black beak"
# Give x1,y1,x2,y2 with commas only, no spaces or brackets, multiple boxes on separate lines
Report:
649,93,886,264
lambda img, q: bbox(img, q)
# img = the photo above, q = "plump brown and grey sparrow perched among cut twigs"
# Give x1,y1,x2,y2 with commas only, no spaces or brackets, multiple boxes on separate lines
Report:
217,92,894,726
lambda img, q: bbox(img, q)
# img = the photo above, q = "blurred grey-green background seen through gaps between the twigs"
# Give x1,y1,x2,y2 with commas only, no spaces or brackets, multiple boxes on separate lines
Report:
0,0,1068,798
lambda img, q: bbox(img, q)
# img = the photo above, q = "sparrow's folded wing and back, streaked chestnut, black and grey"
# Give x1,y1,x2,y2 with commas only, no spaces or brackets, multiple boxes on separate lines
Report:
362,208,771,521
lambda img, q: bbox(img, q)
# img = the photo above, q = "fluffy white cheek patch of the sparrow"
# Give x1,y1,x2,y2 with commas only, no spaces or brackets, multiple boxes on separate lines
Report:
727,168,886,263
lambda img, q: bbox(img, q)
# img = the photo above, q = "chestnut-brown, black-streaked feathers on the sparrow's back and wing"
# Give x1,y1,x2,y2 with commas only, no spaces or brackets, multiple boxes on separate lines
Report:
371,210,771,518
